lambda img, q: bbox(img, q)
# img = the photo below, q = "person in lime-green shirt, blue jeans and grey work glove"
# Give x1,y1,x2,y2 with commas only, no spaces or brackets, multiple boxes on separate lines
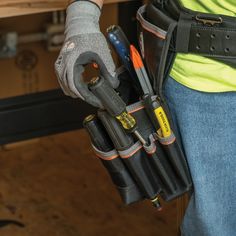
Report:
55,0,236,236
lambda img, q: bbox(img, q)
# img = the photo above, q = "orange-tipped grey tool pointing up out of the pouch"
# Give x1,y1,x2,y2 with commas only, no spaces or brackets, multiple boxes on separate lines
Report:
130,45,154,96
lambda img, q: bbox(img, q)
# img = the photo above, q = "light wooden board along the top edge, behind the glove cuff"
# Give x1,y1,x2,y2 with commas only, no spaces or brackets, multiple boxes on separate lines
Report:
0,0,128,18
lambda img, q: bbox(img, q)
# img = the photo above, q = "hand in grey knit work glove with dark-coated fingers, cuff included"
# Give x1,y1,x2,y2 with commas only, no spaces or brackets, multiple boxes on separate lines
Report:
55,1,119,108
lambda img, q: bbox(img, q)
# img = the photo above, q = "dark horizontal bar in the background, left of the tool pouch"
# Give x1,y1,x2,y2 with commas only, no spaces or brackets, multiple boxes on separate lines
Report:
0,89,95,145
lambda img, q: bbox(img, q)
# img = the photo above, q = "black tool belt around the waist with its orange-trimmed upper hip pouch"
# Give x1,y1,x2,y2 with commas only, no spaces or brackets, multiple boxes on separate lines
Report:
137,0,236,97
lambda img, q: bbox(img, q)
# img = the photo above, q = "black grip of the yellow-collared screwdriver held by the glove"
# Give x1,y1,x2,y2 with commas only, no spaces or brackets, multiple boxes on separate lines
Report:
89,77,126,117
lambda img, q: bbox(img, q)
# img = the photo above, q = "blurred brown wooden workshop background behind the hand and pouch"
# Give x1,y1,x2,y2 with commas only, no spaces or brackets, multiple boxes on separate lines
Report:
0,0,187,236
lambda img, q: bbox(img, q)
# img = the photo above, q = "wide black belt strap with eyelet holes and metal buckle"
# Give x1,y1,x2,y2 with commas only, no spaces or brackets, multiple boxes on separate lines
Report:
176,12,236,59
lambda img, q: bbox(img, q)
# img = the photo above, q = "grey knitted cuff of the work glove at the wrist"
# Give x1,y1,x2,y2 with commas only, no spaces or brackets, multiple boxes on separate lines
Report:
65,1,101,40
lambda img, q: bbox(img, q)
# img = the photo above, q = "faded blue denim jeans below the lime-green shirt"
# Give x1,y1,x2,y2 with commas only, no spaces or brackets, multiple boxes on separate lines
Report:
164,78,236,236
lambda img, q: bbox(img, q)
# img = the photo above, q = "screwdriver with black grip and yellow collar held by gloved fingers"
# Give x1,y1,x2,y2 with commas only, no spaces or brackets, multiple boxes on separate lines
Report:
89,77,147,145
